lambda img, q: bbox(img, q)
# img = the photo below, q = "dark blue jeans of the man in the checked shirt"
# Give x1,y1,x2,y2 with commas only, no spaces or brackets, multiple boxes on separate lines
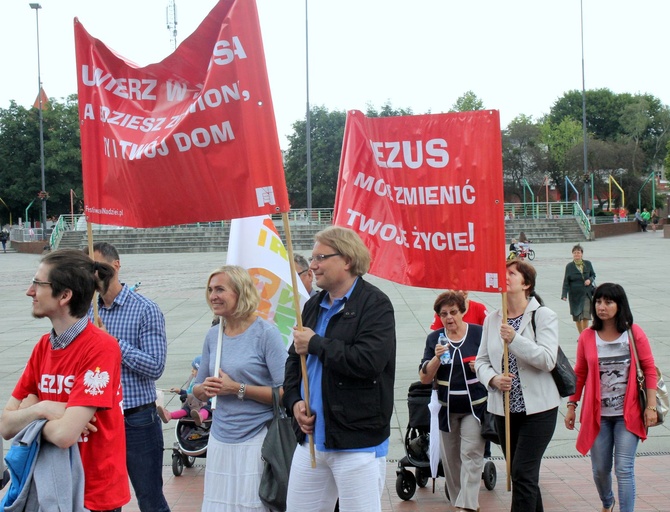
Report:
125,407,170,512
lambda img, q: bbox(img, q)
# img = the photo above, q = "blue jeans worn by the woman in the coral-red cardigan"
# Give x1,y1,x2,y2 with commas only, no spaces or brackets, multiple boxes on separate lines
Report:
591,416,640,512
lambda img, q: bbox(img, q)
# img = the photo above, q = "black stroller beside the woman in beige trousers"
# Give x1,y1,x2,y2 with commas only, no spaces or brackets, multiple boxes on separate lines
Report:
395,382,497,500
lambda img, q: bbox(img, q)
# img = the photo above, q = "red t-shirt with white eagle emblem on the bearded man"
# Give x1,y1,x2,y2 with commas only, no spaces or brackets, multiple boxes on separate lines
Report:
12,322,130,510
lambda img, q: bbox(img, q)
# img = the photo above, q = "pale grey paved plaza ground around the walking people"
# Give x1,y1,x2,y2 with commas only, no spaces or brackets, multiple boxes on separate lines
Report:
0,232,670,511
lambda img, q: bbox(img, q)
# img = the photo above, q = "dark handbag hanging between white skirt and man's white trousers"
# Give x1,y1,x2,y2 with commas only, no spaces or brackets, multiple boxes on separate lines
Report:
258,388,297,512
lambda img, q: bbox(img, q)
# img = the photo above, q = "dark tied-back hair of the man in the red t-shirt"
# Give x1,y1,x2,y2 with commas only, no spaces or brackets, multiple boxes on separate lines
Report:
41,249,114,318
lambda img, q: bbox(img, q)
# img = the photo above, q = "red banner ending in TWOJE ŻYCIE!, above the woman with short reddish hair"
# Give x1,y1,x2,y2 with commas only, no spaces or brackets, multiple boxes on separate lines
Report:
335,110,505,292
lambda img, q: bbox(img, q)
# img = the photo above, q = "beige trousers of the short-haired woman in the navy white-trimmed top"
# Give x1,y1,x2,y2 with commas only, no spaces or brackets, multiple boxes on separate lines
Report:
440,413,486,510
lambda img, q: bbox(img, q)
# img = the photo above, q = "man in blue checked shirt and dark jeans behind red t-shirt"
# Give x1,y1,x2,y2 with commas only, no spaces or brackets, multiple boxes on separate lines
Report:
89,242,170,512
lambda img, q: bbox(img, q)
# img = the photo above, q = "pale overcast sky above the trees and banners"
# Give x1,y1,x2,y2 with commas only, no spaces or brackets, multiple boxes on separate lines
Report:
0,0,670,149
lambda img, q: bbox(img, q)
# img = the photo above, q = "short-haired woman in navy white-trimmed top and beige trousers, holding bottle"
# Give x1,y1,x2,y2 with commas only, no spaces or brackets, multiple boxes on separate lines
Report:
419,291,486,511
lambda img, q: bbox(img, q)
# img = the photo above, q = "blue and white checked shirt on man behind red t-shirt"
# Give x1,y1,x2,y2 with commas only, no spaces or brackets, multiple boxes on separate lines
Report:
89,284,167,409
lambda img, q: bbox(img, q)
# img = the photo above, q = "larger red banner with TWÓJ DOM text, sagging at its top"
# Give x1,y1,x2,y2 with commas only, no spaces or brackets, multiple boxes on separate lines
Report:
75,0,289,227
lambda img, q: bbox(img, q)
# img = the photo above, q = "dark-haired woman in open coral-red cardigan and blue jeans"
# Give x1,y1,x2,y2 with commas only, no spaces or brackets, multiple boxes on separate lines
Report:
565,283,656,512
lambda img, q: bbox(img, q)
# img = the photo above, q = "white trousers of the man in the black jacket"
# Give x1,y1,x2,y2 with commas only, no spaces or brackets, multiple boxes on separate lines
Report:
286,443,386,512
